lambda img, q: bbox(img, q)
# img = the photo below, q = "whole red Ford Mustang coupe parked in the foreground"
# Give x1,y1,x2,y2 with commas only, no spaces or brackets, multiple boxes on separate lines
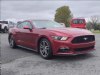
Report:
8,20,95,59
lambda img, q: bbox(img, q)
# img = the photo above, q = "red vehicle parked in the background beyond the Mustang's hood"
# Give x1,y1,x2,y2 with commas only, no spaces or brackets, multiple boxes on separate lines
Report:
70,18,86,29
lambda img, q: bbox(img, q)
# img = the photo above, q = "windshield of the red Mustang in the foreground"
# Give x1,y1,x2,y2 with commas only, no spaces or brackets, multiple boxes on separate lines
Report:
33,20,64,28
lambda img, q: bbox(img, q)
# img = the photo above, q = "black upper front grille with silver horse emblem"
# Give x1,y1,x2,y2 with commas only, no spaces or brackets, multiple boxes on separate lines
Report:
72,35,95,43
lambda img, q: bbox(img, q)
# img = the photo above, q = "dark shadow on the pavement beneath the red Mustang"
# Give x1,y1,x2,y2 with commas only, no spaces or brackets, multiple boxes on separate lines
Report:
12,47,95,61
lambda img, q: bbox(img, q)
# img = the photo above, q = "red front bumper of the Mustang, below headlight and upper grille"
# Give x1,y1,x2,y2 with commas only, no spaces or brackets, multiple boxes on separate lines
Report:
52,41,95,55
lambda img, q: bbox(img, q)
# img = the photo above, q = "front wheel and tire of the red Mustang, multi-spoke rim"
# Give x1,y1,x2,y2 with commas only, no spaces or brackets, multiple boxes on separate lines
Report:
39,38,52,59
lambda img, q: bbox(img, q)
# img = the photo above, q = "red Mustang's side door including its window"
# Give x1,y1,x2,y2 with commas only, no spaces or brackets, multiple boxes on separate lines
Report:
21,21,35,49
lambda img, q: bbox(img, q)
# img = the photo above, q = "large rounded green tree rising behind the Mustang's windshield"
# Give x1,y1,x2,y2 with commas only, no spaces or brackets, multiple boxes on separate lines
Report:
55,6,73,26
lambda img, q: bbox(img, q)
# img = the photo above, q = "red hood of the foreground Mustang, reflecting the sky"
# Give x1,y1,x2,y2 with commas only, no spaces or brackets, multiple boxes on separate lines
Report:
48,28,93,36
